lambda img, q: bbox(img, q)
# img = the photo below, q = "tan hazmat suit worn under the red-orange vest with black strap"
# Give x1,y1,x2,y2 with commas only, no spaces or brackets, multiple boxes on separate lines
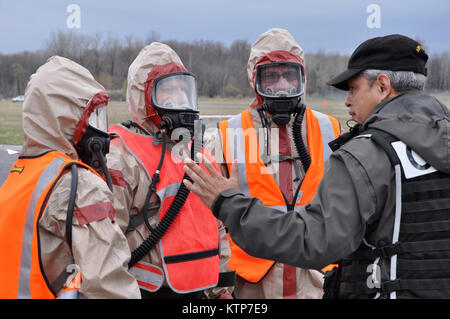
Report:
107,42,233,298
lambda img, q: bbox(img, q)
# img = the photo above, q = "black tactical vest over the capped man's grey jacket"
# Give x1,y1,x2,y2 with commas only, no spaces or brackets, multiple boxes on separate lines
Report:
324,129,450,298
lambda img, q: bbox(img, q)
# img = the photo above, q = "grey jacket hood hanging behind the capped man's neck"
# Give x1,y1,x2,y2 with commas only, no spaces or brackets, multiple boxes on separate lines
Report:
362,91,450,173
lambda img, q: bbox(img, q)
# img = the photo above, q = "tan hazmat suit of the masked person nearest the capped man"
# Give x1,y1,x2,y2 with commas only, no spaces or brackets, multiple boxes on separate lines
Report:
206,28,323,299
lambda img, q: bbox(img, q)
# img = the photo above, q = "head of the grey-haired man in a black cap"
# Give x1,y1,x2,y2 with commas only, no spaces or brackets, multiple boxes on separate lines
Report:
327,34,428,123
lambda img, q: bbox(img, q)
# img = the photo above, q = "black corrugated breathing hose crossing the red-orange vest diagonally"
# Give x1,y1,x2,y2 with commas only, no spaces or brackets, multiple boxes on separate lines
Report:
128,131,201,268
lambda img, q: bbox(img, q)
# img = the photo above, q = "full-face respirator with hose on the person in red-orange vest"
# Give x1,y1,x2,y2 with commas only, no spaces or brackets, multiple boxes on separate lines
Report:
128,72,203,268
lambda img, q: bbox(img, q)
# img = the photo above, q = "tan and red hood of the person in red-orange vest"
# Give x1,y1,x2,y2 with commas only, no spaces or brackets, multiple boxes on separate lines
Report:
127,42,187,134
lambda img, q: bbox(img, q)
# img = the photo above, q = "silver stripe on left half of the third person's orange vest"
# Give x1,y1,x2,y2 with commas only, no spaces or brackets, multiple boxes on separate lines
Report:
227,114,250,196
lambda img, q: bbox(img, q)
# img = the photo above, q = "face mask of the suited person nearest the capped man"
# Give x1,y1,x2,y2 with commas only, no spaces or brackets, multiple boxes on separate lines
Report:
255,62,305,126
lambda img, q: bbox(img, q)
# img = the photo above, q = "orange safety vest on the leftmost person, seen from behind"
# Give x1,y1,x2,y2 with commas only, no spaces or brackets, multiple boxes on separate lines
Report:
0,151,98,299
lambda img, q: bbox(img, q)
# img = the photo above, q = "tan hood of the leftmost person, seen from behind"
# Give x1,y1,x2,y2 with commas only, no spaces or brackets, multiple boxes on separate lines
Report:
22,56,108,160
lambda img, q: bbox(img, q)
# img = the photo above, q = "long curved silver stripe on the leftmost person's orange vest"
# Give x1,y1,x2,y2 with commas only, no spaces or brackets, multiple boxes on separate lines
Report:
17,158,66,298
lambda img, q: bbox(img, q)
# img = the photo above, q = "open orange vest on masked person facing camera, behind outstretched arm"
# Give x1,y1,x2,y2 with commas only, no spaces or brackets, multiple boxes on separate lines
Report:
219,108,340,283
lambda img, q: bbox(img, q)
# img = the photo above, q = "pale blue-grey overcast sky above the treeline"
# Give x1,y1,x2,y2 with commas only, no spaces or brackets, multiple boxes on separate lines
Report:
0,0,450,54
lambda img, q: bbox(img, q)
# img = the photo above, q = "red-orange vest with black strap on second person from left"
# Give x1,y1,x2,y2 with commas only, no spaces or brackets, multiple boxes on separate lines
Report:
109,125,219,293
